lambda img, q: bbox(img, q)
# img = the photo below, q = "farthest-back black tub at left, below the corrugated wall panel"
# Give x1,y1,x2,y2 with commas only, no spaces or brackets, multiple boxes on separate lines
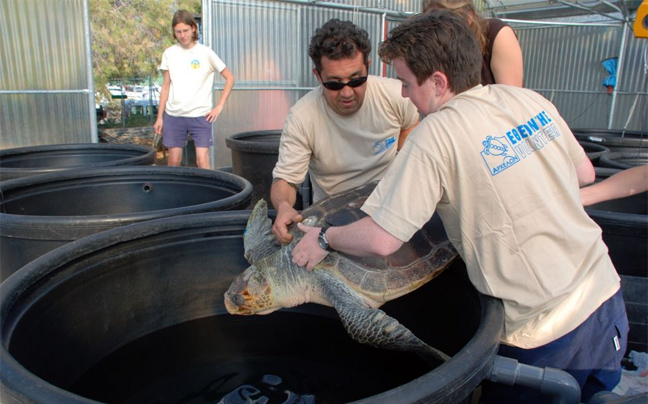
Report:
0,143,156,181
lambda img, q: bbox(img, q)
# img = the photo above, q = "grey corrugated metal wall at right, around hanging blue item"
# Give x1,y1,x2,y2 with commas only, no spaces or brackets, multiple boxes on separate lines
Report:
511,22,648,133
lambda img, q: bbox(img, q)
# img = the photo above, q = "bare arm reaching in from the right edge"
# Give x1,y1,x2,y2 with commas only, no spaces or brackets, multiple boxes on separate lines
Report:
580,165,648,206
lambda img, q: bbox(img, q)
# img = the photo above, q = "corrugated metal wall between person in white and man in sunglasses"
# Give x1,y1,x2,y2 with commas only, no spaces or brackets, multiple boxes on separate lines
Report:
203,0,392,166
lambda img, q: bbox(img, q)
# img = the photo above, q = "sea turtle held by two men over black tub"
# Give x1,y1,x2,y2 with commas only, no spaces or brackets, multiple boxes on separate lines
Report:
225,183,457,360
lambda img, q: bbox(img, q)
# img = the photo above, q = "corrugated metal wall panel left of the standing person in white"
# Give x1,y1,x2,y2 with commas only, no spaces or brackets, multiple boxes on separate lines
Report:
0,0,97,149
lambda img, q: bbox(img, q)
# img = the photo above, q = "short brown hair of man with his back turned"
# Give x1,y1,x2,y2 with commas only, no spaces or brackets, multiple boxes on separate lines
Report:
378,9,482,94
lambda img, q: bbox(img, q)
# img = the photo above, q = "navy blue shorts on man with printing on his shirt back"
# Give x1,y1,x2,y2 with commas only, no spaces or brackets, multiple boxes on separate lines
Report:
481,290,629,404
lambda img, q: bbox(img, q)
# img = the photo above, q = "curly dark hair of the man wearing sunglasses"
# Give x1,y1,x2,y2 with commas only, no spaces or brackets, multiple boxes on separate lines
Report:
308,18,371,72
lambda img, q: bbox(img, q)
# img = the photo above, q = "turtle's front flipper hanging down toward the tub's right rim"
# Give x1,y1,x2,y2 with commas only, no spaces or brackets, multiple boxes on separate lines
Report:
324,275,450,362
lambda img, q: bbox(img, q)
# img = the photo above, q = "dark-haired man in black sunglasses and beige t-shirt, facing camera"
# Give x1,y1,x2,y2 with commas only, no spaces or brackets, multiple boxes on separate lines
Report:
270,19,419,243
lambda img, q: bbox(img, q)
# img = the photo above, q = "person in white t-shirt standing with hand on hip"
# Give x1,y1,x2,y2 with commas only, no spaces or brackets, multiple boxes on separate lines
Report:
153,10,234,169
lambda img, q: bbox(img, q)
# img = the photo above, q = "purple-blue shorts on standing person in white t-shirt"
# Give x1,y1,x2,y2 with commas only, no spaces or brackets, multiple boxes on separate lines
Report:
162,112,214,147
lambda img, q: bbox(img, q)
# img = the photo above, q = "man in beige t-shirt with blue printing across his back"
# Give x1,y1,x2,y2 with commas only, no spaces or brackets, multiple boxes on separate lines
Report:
293,10,628,404
